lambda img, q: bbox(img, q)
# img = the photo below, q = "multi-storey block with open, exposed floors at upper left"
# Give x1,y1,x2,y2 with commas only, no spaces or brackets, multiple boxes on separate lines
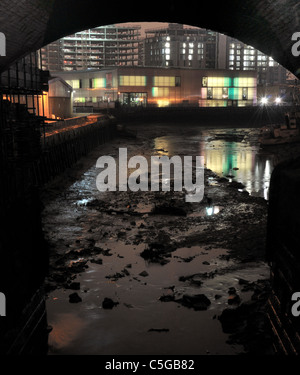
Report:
41,25,141,71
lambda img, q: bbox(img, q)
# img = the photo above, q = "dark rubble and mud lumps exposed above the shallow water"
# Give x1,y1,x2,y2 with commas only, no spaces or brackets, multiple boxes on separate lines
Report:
45,125,274,352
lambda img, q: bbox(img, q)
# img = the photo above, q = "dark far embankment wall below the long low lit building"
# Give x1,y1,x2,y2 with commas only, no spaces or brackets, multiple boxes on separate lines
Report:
110,106,291,127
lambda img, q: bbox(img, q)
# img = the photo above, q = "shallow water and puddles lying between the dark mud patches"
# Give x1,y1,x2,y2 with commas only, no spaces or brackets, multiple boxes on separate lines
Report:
43,124,300,355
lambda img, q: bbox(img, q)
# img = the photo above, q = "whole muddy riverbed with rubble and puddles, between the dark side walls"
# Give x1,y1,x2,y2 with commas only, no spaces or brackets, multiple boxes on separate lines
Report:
43,125,300,355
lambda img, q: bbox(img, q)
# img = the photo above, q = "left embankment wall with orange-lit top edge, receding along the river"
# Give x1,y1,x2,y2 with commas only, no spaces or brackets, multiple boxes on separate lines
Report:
35,115,116,185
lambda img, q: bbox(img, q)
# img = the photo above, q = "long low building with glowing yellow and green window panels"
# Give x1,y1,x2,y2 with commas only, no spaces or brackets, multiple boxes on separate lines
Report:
53,67,257,111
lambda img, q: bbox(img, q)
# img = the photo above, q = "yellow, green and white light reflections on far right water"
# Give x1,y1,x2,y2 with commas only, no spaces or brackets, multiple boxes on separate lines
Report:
155,129,275,199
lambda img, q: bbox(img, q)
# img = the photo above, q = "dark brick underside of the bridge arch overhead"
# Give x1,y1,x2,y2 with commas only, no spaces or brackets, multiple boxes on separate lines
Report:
0,0,300,77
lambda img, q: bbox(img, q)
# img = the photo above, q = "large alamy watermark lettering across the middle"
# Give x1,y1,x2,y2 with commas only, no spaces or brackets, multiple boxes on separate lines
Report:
96,148,204,202
